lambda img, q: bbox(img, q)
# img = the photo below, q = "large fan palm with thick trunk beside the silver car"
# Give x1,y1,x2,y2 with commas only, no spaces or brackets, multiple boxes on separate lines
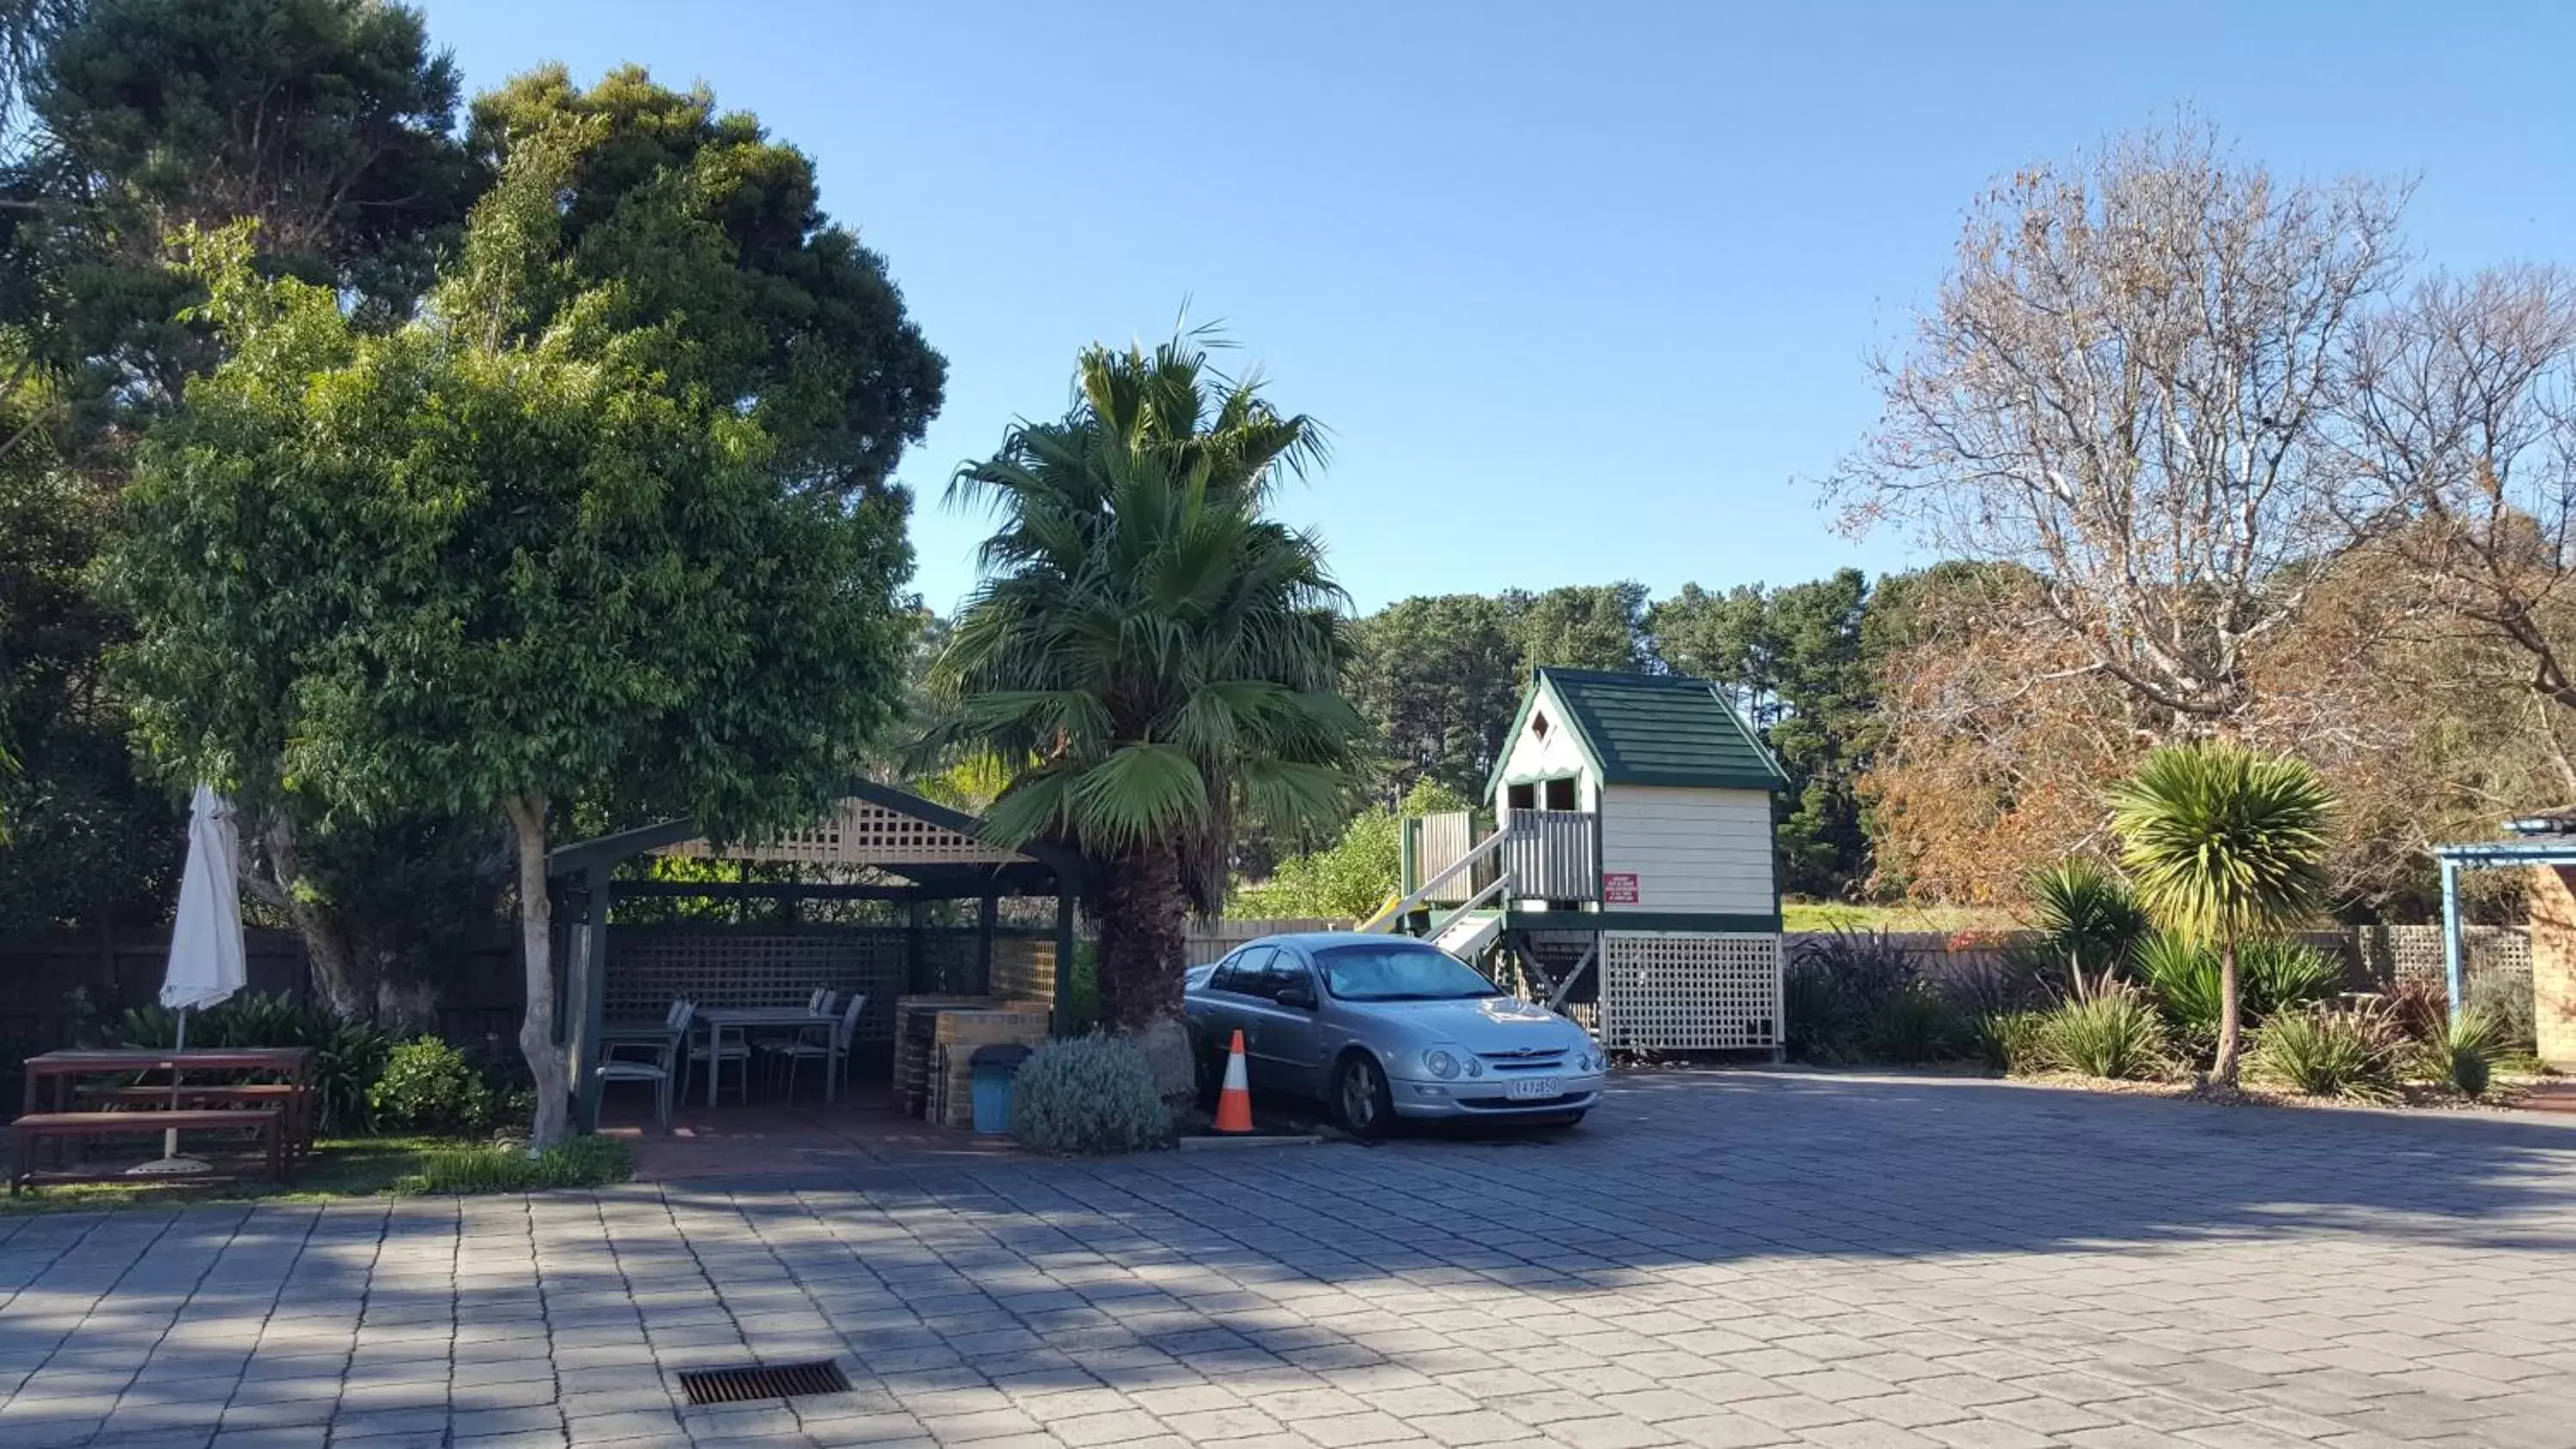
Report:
927,332,1360,1032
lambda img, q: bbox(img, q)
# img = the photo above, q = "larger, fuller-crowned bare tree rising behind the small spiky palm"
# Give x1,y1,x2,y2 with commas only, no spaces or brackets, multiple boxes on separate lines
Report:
1832,118,2403,736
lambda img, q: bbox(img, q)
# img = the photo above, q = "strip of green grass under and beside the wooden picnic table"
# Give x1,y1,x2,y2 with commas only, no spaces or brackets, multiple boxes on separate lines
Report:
0,1137,634,1212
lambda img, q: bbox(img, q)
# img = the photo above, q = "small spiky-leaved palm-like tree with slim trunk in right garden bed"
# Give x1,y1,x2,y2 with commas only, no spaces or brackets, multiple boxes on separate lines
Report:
2110,743,2334,1086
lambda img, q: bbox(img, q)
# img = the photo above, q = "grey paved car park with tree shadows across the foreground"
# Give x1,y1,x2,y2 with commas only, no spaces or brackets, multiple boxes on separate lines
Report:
0,1073,2576,1449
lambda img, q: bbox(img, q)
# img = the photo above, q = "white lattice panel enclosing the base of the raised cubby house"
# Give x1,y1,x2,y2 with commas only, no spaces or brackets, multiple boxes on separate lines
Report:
1600,931,1780,1052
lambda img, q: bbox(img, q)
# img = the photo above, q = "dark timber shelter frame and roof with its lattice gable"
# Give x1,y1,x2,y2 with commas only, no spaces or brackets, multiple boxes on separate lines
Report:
546,779,1082,1130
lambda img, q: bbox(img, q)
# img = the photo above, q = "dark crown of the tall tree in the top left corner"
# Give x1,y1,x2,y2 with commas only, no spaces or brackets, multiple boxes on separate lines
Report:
0,0,477,435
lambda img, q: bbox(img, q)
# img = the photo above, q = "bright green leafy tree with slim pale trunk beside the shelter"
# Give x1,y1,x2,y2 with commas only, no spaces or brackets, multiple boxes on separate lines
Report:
113,126,912,1145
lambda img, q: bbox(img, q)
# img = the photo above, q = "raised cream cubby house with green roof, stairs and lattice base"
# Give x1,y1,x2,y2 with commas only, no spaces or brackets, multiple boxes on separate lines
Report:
1360,670,1788,1052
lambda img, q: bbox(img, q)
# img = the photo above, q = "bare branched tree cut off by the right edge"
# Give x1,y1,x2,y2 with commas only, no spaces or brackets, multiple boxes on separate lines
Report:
2347,268,2576,797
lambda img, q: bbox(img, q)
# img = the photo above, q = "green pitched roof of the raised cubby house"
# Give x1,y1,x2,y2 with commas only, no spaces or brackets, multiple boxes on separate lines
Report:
1512,670,1788,790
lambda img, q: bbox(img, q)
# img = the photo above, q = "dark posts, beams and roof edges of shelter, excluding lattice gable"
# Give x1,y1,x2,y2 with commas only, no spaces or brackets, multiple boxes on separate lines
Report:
546,779,1082,1132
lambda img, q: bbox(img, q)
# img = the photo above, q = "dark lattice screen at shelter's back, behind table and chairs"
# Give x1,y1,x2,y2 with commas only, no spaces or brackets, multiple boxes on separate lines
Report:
603,926,917,1042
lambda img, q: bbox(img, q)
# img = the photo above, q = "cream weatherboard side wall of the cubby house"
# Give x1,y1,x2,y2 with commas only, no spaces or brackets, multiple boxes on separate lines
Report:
1600,785,1777,916
